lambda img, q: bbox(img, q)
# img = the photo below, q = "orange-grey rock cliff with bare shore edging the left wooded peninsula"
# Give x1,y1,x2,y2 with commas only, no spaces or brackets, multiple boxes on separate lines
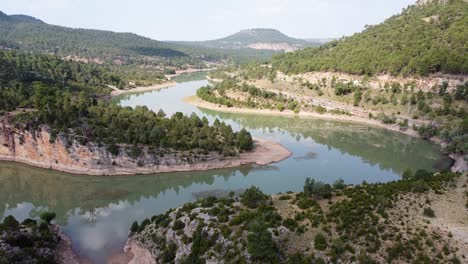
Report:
0,118,290,175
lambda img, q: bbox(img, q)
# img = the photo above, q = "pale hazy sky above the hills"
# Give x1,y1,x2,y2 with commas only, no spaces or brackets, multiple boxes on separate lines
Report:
0,0,415,40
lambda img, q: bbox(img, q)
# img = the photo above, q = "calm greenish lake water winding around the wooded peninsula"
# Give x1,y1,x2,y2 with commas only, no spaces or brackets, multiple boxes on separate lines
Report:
0,74,451,263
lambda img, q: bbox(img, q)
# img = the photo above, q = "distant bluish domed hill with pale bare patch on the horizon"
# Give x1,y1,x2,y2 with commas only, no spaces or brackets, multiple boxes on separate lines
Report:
178,28,320,51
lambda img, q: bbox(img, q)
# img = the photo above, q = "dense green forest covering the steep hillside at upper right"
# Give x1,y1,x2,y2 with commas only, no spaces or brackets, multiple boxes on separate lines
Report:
272,0,468,75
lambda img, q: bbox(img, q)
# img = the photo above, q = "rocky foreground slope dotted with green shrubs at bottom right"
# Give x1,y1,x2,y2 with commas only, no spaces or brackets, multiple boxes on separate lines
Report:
130,170,467,263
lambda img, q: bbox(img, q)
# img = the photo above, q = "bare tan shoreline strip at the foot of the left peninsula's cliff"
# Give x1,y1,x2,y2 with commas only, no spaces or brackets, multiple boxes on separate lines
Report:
0,138,292,176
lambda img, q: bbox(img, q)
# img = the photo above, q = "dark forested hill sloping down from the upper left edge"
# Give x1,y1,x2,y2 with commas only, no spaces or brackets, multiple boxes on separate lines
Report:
0,13,199,62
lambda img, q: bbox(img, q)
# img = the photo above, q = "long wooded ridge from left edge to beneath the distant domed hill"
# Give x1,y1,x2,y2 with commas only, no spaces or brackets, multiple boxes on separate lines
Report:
0,12,278,67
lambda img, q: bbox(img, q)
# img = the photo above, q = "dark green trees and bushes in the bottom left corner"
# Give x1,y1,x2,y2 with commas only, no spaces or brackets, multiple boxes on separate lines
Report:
0,212,60,263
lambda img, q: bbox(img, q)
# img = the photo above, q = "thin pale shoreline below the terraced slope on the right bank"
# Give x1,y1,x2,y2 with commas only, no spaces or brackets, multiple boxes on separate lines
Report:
184,95,468,172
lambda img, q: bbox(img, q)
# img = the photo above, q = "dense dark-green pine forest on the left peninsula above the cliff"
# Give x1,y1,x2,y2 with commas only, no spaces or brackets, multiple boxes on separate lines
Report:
0,51,252,153
